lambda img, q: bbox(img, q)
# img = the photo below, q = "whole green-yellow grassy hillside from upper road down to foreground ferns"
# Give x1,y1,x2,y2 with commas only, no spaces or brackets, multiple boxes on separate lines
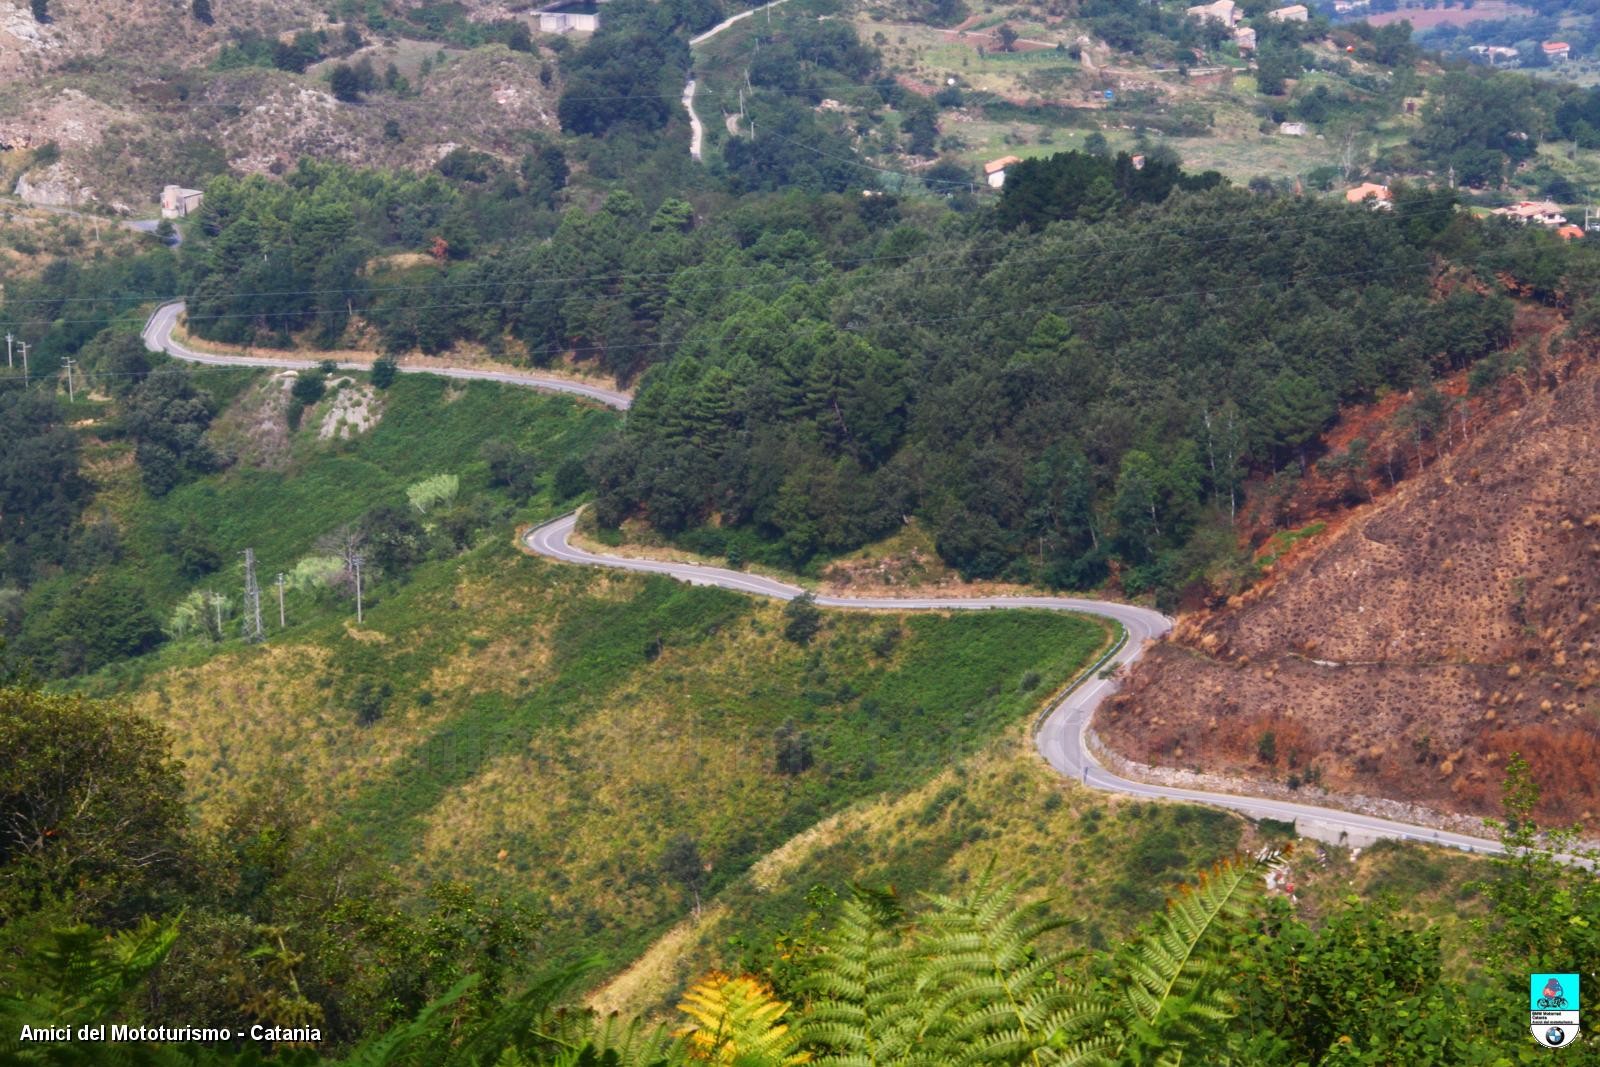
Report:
53,361,1497,1011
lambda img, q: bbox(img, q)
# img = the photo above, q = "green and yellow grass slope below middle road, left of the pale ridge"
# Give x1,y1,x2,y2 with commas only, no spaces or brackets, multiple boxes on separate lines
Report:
121,542,1106,963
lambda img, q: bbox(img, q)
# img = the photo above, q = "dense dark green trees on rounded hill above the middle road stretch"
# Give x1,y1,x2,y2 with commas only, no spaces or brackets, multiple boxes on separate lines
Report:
594,185,1510,601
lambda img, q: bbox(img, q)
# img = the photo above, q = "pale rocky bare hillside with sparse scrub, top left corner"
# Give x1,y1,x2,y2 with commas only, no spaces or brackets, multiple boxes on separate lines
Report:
0,0,560,211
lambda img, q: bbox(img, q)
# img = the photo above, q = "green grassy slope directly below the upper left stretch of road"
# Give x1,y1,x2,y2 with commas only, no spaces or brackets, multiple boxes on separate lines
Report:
56,368,618,693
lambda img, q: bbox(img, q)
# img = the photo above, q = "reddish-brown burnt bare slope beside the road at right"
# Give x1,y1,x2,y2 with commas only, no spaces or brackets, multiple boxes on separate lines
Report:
1099,350,1600,827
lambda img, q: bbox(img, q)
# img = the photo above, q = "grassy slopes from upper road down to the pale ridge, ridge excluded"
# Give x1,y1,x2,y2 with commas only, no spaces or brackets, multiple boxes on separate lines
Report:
62,361,1107,985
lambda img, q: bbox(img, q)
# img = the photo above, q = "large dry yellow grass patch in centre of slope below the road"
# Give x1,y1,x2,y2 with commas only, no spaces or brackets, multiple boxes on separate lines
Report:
421,609,803,917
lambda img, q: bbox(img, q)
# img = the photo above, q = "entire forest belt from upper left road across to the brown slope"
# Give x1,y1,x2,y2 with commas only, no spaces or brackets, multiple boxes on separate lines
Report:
159,154,1561,595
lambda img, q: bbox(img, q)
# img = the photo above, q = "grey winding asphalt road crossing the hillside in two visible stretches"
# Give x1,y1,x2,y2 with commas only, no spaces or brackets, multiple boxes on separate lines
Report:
144,302,1504,853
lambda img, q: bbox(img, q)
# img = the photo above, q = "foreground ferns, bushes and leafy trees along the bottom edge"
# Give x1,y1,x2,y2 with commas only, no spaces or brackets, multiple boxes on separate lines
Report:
0,675,1600,1067
